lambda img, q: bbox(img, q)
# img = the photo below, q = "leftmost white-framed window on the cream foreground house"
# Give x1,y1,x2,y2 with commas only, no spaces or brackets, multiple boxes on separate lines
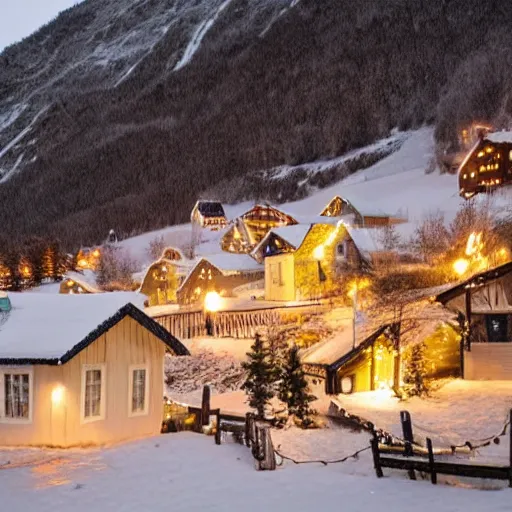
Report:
0,368,33,422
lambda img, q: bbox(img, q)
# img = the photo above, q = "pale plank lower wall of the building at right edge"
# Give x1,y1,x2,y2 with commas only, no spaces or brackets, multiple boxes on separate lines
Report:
464,343,512,380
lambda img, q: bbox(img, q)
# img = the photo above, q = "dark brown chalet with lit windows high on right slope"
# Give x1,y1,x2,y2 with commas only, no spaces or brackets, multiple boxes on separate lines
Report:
458,132,512,199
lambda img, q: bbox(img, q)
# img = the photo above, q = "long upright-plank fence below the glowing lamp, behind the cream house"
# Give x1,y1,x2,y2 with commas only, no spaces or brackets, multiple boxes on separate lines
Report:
154,304,328,339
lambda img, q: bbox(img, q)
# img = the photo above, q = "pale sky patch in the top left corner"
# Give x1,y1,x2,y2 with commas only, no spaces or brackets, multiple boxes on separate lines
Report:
0,0,80,51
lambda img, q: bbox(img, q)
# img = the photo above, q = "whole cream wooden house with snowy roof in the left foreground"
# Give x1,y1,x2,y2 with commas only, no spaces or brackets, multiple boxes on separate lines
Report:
0,293,188,447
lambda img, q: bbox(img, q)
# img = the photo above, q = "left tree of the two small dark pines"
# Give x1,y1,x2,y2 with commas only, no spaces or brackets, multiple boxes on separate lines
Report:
242,334,274,419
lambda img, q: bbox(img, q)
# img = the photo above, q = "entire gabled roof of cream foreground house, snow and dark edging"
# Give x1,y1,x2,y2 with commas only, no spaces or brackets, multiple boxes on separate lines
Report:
0,292,188,365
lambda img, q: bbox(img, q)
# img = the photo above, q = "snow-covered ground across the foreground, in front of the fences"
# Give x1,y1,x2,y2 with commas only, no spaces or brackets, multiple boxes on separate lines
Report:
0,434,510,512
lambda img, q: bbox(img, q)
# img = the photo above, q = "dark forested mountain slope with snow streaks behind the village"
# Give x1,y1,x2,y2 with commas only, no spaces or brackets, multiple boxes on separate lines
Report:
0,0,512,245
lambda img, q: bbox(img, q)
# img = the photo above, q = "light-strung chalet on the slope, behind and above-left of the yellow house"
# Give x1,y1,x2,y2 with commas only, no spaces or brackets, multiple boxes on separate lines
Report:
221,204,297,253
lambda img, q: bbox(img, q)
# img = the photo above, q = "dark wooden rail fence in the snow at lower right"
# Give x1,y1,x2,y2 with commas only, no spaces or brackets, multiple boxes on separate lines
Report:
371,409,512,487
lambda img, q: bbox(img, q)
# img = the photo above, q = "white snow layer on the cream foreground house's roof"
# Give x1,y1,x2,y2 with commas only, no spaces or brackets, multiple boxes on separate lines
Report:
0,292,184,364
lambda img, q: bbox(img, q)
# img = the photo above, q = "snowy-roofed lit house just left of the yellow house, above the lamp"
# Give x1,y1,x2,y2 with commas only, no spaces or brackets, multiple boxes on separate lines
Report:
177,253,264,305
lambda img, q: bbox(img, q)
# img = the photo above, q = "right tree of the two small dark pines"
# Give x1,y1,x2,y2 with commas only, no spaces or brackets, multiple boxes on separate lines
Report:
279,345,316,427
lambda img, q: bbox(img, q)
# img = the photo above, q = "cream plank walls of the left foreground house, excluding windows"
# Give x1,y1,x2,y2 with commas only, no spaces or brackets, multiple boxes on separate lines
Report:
0,317,165,446
